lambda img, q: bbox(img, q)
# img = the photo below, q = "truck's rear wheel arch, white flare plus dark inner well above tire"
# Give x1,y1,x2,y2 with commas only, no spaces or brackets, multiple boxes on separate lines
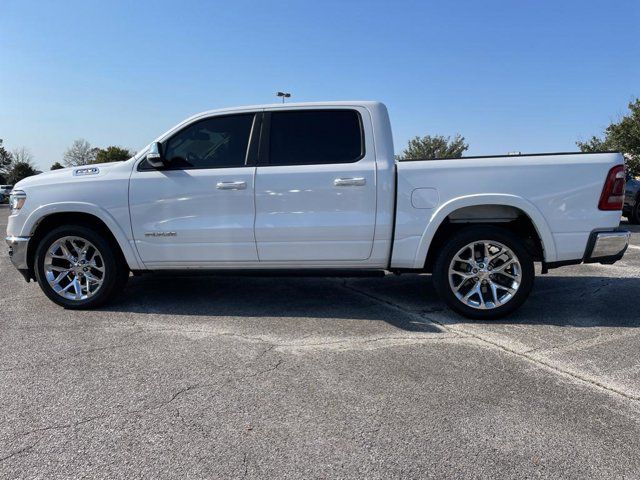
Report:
414,194,556,270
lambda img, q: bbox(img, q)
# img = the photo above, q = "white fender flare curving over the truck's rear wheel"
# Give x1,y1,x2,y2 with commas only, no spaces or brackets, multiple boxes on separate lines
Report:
414,193,557,268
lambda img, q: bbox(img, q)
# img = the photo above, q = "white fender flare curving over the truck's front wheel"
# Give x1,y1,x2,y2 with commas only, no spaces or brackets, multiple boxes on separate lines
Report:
21,202,142,270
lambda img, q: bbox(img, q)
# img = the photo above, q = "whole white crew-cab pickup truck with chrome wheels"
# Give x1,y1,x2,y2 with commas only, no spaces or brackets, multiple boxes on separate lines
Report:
6,102,629,318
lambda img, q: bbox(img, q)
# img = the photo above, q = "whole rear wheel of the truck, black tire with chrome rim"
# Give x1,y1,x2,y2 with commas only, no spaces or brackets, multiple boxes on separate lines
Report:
433,226,535,320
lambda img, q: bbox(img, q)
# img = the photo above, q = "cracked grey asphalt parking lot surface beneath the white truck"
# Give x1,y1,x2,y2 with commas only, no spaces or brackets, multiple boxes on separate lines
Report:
0,206,640,479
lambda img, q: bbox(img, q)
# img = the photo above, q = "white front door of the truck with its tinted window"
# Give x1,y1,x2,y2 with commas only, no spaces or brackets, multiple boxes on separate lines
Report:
129,113,260,268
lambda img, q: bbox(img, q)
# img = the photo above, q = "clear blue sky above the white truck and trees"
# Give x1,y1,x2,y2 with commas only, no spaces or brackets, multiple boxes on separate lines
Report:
0,0,640,170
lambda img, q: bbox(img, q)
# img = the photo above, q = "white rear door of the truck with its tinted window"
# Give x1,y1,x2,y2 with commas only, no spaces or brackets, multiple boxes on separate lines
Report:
255,107,376,264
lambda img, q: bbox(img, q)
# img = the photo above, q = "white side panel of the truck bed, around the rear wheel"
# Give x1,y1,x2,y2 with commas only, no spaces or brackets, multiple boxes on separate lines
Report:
391,153,623,268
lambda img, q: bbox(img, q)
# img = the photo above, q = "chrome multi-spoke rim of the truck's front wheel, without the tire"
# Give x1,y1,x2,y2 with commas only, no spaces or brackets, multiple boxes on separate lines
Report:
44,236,105,300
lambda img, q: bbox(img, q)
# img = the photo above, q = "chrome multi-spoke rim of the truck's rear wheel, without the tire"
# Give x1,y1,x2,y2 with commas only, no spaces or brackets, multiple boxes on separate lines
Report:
448,240,522,310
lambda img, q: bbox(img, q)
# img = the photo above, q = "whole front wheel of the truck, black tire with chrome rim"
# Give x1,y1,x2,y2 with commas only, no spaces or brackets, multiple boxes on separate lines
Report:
34,225,129,310
